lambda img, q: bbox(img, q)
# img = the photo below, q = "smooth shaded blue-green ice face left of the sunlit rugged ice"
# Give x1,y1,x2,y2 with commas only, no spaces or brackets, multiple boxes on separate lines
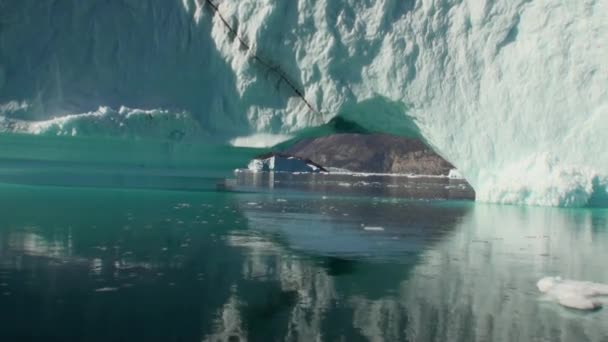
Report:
0,0,247,134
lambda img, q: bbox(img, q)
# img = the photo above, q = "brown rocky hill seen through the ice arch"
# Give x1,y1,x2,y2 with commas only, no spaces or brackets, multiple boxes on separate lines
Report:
285,134,454,176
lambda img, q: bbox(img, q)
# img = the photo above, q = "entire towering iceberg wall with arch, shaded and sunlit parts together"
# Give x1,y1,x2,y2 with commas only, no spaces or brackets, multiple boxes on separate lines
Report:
0,0,608,206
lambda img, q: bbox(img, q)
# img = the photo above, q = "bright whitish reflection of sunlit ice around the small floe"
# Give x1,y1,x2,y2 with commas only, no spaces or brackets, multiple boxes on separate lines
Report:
400,205,608,341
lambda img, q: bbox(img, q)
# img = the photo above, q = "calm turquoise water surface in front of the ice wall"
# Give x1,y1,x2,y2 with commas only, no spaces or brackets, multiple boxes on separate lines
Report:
0,137,608,341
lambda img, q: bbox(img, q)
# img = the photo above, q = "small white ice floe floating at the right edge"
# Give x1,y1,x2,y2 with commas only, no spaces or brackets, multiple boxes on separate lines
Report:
536,277,608,310
